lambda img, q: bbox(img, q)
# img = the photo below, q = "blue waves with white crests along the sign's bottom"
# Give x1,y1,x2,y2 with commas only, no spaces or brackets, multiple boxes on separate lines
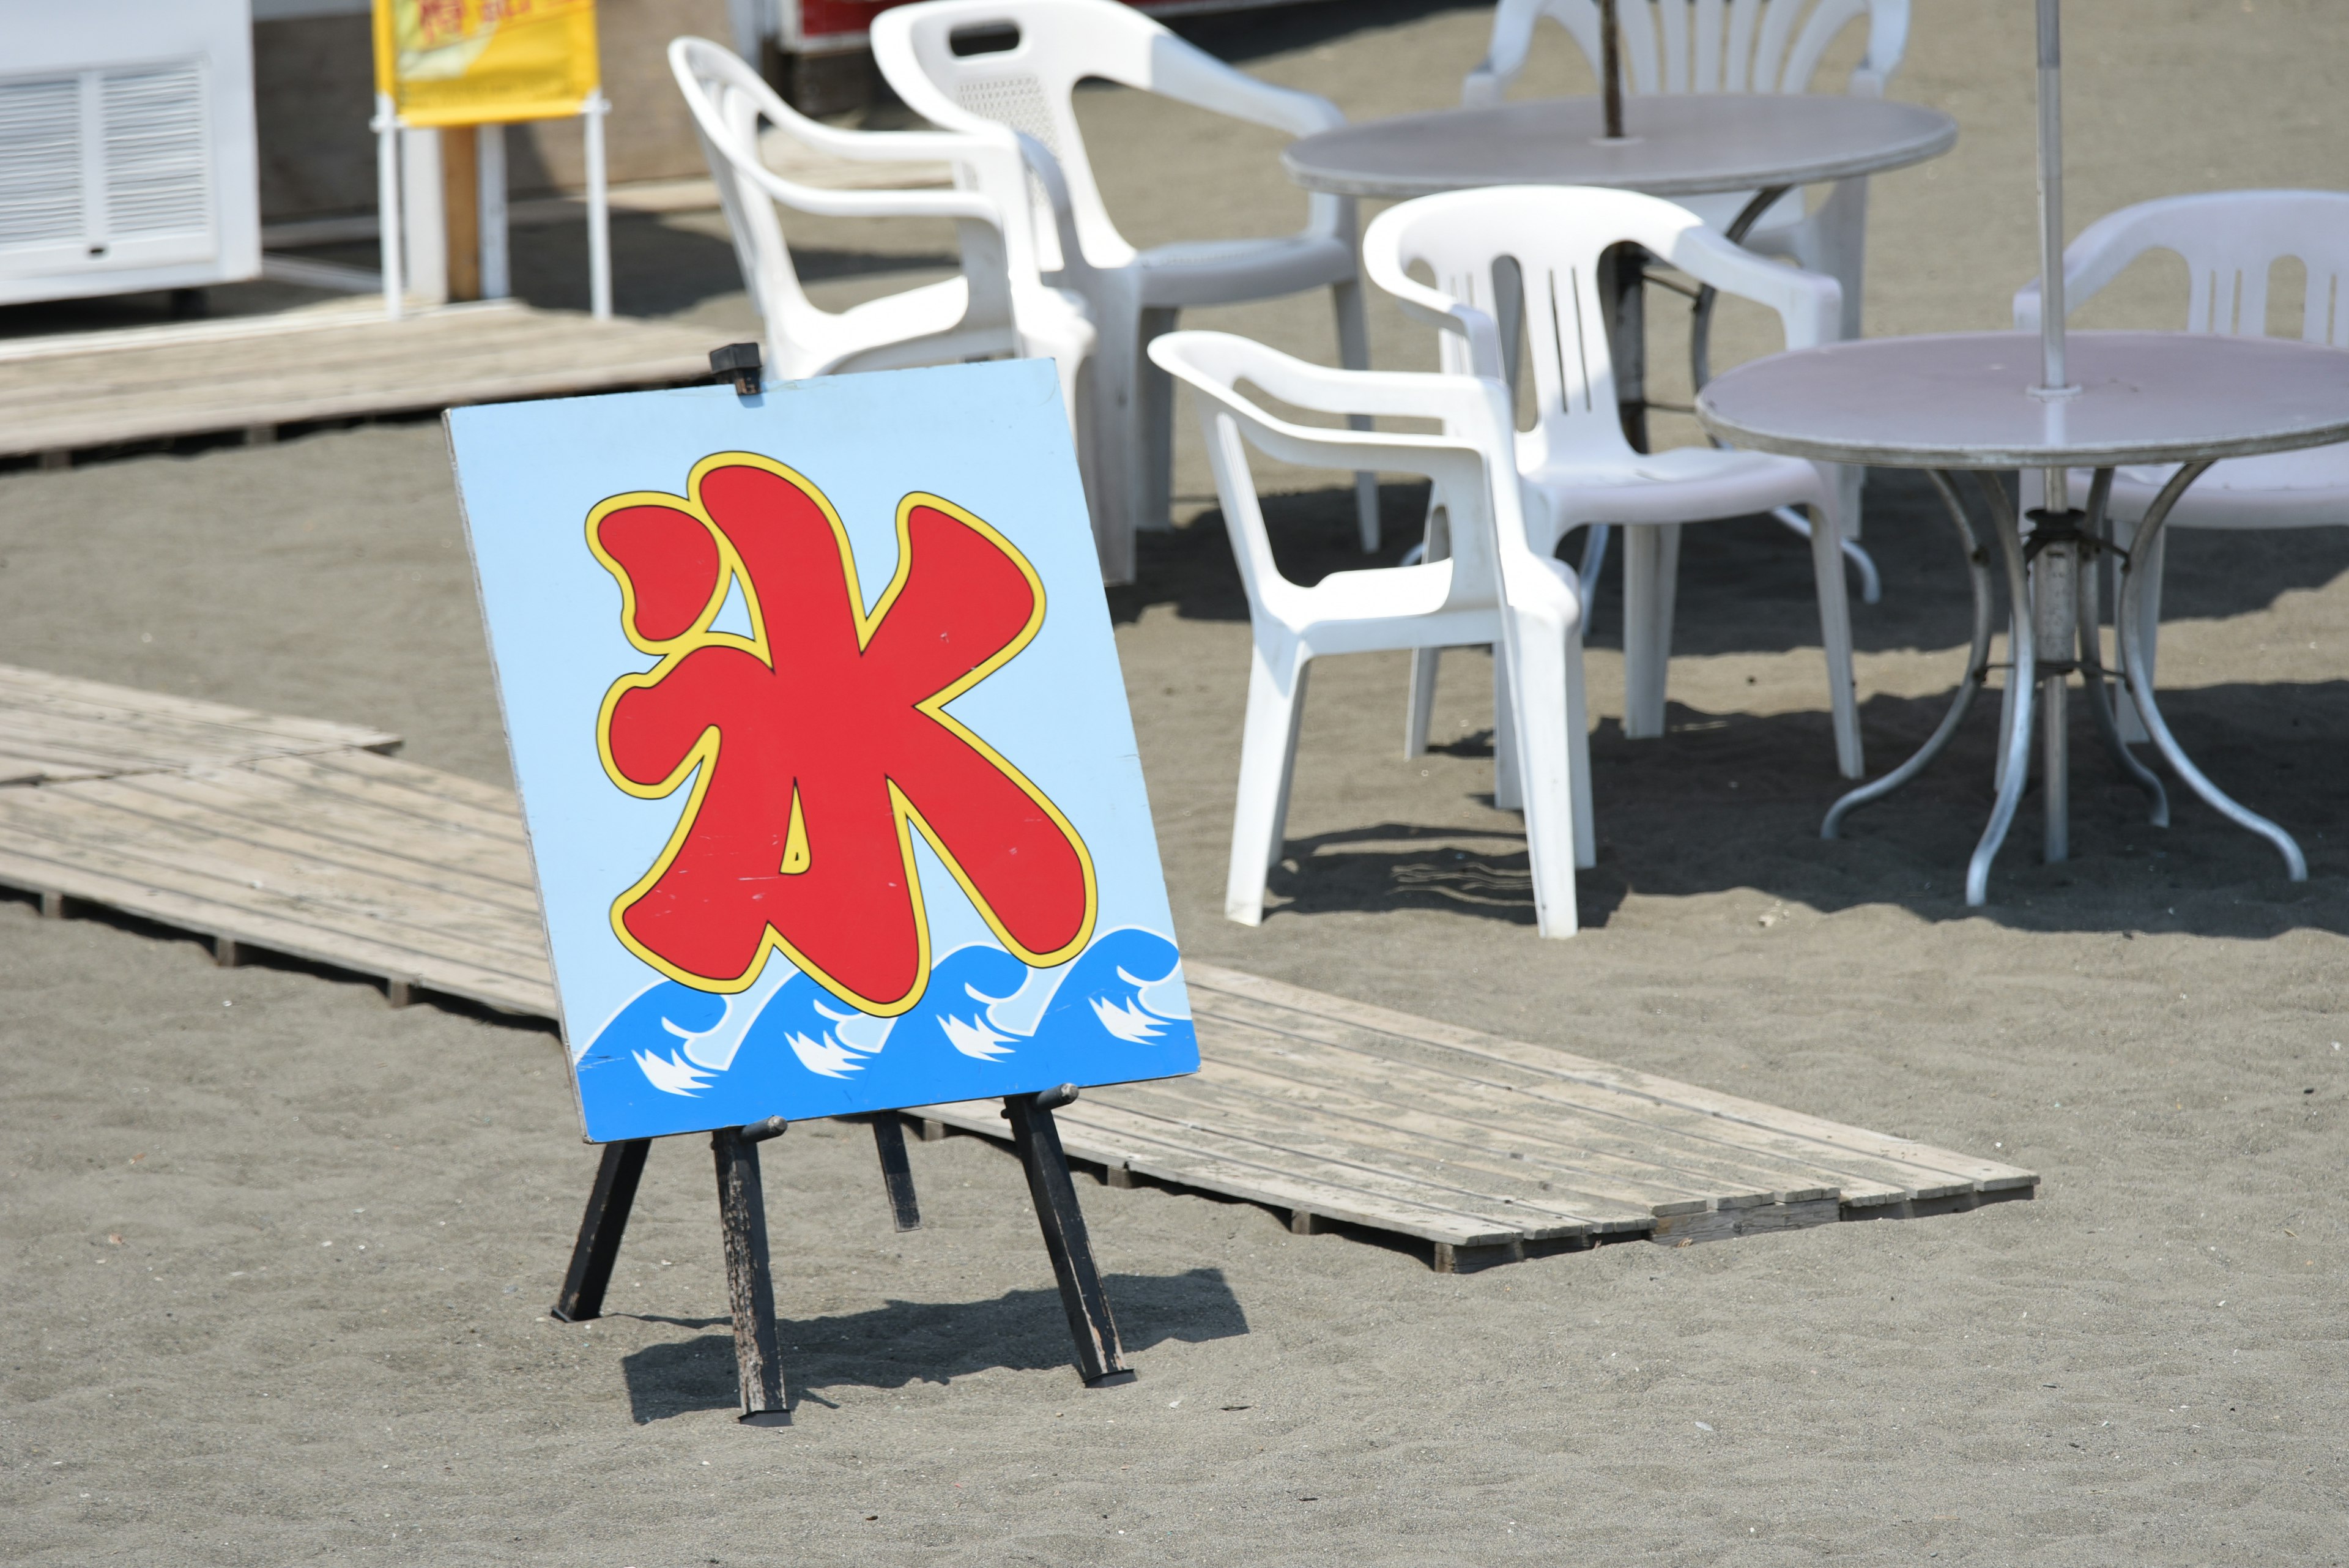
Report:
578,929,1198,1140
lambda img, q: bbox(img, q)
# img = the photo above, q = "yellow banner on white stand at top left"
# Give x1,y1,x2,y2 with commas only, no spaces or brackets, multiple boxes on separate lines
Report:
376,0,601,125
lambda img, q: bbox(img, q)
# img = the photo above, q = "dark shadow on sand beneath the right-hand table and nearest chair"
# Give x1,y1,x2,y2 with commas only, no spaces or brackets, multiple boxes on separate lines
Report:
1266,682,2349,938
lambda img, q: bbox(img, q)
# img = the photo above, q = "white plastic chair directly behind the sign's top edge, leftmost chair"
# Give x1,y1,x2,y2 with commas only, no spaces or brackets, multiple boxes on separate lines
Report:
669,37,1094,451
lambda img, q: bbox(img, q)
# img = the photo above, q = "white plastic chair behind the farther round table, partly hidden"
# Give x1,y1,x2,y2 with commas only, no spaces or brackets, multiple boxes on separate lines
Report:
1461,0,1910,338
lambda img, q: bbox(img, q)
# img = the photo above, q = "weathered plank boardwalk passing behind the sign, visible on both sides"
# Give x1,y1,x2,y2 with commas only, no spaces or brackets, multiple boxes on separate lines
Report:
0,670,2039,1269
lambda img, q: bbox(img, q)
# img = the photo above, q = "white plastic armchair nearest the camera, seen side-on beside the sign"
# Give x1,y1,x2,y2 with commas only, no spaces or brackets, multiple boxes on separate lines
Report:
1149,332,1597,935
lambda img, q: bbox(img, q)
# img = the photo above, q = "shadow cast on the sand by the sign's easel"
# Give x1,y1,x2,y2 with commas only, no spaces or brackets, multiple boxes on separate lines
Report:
620,1269,1247,1425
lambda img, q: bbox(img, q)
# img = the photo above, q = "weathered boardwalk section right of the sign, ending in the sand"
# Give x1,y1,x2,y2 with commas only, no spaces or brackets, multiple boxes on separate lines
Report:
911,959,2039,1272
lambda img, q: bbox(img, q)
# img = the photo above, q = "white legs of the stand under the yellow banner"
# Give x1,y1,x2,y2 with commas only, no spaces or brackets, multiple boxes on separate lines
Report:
369,87,610,322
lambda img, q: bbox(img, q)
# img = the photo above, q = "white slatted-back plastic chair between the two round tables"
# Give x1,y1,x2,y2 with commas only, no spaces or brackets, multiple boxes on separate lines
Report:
1362,186,1860,778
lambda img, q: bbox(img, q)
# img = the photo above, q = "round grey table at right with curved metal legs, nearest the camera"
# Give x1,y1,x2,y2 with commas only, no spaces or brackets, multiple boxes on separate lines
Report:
1696,332,2349,905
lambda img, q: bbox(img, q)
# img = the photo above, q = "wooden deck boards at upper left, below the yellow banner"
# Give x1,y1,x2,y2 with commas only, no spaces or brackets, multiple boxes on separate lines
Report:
0,301,721,461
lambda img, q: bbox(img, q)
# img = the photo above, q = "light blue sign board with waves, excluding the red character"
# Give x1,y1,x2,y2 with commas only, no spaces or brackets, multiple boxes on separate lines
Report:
448,360,1198,1142
